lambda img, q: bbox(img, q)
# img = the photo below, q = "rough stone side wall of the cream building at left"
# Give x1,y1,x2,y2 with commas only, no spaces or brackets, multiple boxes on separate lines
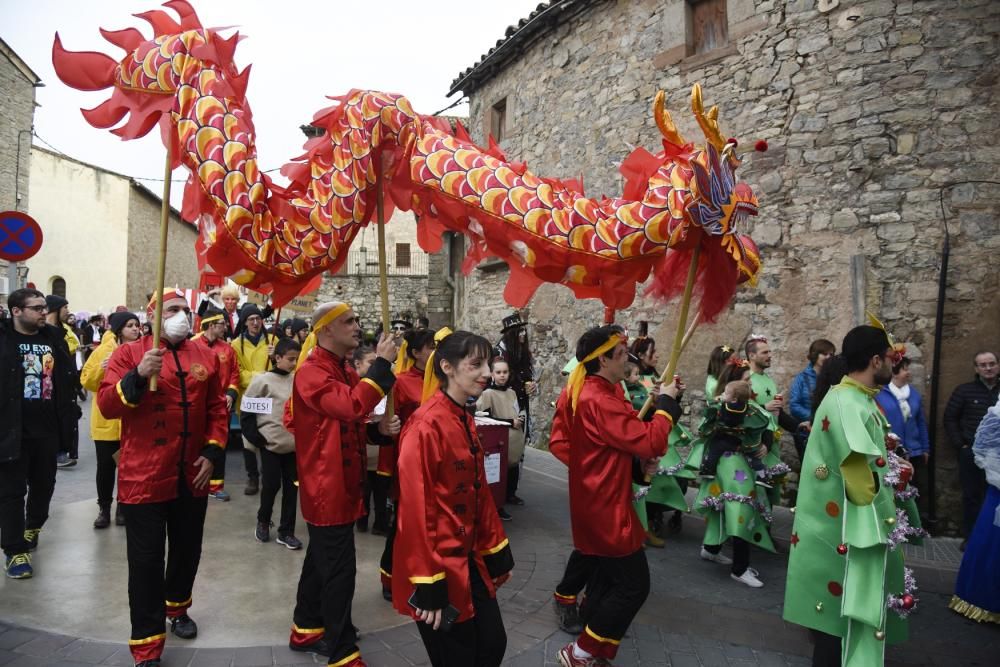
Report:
126,182,201,312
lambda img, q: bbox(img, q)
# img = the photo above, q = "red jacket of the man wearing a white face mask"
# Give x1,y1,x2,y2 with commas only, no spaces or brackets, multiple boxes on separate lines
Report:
97,336,229,504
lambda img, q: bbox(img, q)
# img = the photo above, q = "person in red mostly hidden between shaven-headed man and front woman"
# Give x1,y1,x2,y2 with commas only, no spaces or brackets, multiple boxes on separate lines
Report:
372,329,435,601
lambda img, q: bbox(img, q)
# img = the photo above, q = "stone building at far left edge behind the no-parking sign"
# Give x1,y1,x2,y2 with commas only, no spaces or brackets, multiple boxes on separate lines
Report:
0,39,41,298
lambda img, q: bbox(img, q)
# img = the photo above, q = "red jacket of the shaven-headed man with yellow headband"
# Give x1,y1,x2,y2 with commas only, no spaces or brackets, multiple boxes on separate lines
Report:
285,346,395,526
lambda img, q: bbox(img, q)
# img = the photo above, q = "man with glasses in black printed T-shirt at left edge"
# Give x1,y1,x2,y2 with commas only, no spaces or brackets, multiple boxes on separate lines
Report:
0,289,77,579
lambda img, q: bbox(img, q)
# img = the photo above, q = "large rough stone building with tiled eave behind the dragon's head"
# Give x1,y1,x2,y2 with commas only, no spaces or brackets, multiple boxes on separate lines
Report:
453,0,1000,530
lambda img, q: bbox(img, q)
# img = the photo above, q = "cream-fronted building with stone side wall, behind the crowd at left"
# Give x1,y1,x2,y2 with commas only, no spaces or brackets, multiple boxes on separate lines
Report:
25,146,200,313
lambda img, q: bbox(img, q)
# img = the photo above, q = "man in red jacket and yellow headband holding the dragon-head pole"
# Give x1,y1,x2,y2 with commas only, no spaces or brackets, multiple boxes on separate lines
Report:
557,325,680,667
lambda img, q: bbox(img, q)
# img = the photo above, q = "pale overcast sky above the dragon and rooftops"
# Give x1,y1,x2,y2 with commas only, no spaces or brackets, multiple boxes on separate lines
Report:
0,0,539,205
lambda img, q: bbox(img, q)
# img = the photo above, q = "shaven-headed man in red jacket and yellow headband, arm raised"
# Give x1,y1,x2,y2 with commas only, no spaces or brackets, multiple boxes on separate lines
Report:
285,302,399,667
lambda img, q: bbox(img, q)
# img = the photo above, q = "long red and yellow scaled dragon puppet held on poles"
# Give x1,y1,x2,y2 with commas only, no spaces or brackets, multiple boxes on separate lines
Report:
52,0,760,320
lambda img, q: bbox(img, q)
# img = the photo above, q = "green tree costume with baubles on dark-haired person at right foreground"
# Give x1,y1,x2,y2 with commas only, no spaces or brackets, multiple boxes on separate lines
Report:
783,377,907,667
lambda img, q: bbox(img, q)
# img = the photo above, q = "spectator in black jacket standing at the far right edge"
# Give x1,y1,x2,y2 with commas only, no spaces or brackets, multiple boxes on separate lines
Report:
944,352,1000,550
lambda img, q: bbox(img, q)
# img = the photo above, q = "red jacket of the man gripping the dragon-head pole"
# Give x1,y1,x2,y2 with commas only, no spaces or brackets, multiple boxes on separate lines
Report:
553,375,680,557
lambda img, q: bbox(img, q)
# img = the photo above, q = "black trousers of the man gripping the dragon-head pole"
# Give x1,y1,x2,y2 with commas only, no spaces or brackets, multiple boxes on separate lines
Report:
578,549,649,660
